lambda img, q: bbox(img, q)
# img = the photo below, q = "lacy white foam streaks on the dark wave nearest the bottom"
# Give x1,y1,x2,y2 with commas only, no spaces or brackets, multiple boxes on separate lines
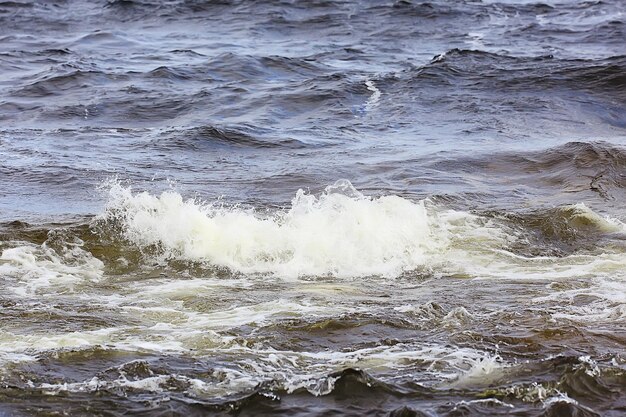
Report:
17,343,504,396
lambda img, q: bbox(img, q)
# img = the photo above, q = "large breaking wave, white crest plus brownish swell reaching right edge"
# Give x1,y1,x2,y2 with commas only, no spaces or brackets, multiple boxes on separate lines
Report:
92,180,625,278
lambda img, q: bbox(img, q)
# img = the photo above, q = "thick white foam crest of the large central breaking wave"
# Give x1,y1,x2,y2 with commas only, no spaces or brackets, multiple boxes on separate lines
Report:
104,180,456,277
